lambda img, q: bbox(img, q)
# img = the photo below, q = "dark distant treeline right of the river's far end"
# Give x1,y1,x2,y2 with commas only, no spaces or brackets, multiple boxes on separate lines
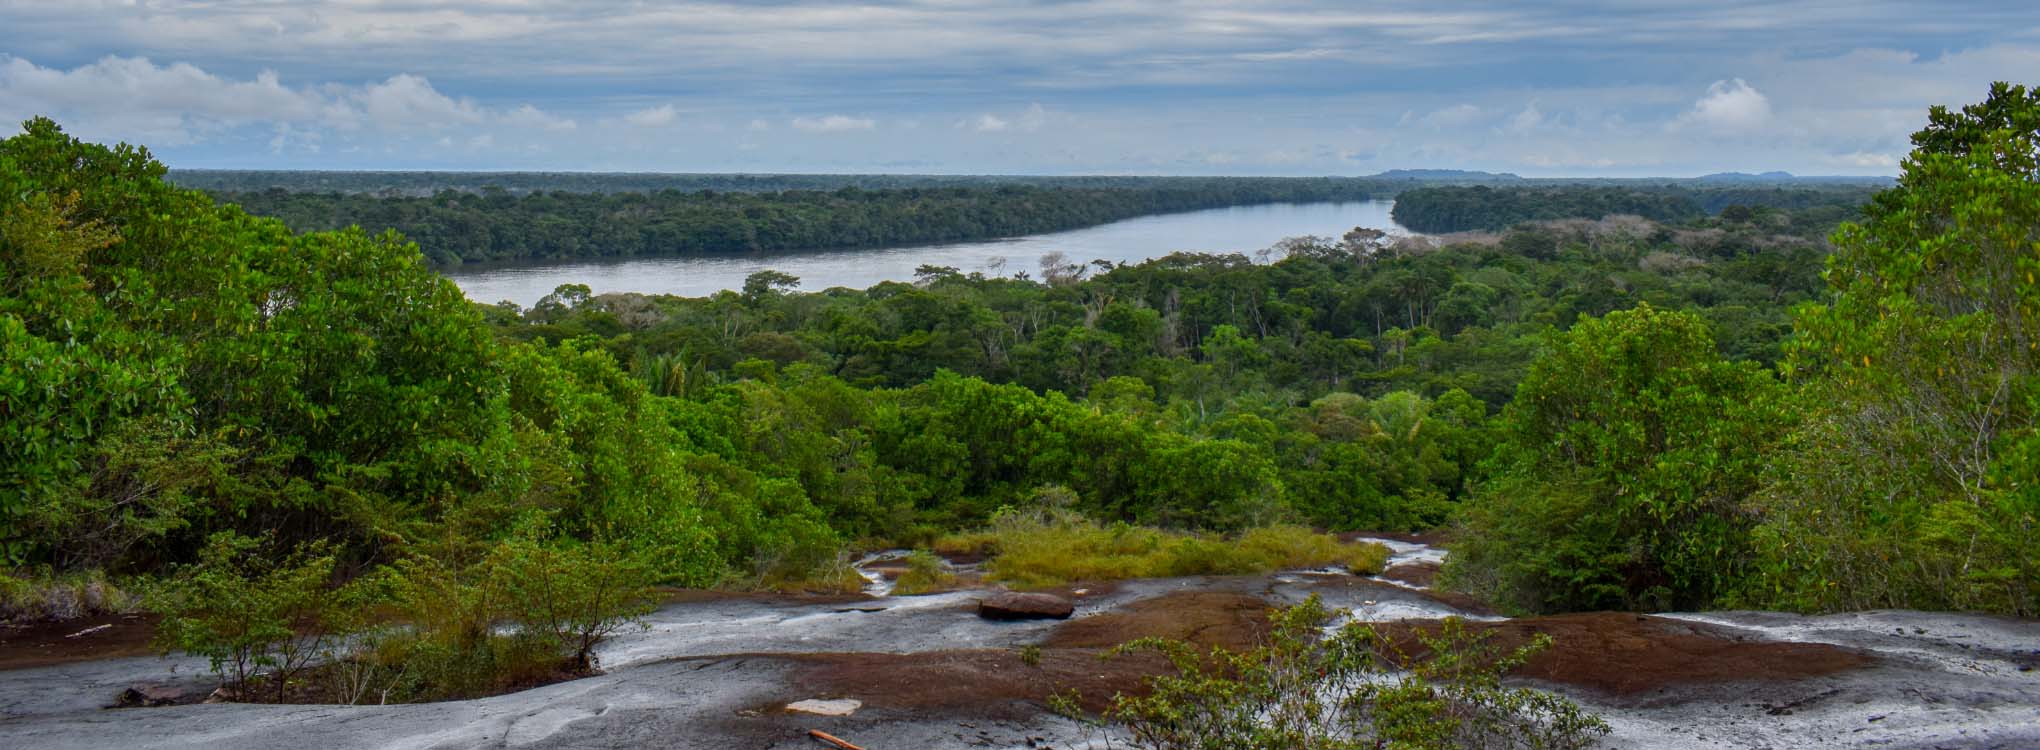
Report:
1393,185,1875,234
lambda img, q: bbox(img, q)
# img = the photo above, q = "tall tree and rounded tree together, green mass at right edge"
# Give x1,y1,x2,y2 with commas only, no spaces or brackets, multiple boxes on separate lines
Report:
1446,84,2040,615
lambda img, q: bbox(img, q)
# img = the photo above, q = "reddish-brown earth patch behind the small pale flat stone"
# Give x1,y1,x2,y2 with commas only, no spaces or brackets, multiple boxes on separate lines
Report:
785,648,1169,719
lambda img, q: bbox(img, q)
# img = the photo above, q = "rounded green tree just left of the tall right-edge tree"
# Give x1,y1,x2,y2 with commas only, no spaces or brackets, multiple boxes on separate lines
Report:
1446,306,1793,611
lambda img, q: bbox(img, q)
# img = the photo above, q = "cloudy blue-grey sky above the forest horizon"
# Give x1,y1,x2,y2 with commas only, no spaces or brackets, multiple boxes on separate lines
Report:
0,0,2040,177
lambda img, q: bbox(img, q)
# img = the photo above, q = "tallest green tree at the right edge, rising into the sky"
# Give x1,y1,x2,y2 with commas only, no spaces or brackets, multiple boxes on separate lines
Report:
1746,84,2040,615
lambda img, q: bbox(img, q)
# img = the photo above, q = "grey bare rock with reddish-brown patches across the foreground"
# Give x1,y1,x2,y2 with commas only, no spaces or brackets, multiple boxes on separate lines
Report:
0,542,2040,750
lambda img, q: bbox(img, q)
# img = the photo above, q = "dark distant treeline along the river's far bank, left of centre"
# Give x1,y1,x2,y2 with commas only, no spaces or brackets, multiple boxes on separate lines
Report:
214,177,1391,267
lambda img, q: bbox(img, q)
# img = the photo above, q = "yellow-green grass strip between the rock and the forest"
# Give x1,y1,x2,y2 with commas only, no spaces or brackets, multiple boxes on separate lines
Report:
936,514,1389,589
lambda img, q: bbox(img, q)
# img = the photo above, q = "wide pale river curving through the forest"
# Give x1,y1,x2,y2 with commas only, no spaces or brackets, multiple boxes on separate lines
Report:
447,200,1406,308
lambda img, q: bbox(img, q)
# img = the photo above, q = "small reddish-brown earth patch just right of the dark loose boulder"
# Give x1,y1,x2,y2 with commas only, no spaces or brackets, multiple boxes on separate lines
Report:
1042,591,1271,648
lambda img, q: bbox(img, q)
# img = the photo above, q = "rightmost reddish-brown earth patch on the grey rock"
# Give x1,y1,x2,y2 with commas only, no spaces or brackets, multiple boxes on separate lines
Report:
1377,611,1873,697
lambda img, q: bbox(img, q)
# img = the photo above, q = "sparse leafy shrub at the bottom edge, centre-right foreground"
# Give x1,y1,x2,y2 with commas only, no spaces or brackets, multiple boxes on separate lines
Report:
1055,597,1610,750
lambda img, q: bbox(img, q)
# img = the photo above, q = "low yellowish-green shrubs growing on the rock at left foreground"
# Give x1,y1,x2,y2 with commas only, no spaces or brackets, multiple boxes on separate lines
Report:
149,532,653,703
